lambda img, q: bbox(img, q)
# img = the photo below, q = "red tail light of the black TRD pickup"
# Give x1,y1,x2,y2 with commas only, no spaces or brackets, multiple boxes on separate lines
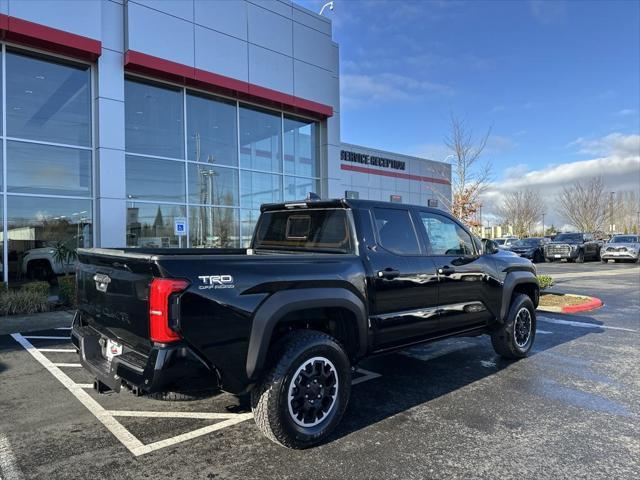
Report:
149,278,189,343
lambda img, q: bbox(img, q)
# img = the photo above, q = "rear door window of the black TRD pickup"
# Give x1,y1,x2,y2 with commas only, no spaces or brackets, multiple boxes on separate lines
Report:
373,208,420,255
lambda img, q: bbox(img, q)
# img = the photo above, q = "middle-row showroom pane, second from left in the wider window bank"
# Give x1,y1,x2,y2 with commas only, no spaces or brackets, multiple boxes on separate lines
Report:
188,163,238,206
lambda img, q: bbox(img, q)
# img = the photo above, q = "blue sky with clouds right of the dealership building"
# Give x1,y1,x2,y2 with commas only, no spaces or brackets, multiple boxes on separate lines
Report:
294,0,640,224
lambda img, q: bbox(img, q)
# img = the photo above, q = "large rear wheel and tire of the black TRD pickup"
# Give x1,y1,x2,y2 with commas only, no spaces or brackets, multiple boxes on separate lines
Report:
251,330,351,449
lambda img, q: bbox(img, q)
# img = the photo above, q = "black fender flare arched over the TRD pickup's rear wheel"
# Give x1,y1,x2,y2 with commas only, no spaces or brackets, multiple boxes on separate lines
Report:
247,288,368,380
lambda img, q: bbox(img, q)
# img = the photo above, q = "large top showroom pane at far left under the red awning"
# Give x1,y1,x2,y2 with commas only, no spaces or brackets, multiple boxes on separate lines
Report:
6,52,91,147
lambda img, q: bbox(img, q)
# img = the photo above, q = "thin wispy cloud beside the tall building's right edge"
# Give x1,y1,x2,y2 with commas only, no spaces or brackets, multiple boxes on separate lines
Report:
340,73,453,107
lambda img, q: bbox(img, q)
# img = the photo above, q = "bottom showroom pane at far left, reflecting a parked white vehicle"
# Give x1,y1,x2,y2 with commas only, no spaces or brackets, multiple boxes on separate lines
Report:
7,195,93,280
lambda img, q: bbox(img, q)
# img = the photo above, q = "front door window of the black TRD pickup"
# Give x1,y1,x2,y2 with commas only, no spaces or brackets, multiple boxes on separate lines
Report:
420,212,476,256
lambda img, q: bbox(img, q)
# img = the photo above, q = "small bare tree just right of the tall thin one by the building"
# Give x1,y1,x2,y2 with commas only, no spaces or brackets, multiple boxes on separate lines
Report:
497,190,545,237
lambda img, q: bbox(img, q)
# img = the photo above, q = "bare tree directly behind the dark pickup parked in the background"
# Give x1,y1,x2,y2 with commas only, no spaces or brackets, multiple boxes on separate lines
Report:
558,177,607,233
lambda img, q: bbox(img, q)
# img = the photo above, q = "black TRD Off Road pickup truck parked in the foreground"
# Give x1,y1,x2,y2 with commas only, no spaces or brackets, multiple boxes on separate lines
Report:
71,200,539,448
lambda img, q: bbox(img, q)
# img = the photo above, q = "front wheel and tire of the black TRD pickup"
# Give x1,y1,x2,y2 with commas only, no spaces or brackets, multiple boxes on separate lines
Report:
491,293,536,359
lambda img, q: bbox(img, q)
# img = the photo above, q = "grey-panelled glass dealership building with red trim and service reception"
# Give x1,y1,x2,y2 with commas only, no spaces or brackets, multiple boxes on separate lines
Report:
0,0,451,281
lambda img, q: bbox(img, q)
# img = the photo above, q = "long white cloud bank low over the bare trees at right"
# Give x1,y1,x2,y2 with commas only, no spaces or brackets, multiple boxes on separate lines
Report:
484,133,640,225
